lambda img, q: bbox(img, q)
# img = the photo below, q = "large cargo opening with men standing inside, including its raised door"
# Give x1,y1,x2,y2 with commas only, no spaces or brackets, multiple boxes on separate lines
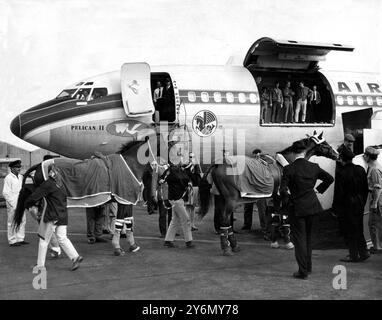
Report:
243,38,354,126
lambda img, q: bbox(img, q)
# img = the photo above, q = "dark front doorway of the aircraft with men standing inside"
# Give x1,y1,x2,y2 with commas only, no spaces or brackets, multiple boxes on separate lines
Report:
151,72,176,123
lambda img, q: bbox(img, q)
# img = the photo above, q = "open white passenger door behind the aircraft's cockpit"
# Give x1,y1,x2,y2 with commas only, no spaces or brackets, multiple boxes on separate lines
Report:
121,62,155,117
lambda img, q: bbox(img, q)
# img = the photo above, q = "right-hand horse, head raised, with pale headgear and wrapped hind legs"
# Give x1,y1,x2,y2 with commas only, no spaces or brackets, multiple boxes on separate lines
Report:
198,132,338,256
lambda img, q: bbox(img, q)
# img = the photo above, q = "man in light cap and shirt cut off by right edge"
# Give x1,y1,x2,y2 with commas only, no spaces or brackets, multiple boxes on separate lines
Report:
364,147,382,254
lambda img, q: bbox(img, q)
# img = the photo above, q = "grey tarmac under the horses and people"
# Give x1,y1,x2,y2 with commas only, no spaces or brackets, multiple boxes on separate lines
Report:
0,206,382,300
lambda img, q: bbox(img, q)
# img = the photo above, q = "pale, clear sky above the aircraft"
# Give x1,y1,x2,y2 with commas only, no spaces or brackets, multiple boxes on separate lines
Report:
0,0,382,150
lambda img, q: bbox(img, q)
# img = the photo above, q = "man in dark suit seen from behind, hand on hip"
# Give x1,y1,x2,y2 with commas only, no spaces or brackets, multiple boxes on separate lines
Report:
280,141,334,279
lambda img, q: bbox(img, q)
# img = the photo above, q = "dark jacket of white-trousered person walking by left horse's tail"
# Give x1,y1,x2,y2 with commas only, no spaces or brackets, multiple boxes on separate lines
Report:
25,178,68,226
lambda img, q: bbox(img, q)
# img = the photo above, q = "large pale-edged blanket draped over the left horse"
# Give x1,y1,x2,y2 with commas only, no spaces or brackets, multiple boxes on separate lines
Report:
42,154,142,208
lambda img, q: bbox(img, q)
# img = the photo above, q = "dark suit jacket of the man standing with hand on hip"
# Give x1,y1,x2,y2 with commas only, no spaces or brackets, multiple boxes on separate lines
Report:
280,158,334,217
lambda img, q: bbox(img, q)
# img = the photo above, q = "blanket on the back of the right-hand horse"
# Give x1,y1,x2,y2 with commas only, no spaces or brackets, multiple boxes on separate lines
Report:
226,156,274,198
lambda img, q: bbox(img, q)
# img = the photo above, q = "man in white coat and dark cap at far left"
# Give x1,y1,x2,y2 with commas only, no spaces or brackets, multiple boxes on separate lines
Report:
3,160,28,247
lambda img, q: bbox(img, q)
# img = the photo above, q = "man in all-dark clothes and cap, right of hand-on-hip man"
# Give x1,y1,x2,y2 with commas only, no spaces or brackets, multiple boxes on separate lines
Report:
336,149,370,262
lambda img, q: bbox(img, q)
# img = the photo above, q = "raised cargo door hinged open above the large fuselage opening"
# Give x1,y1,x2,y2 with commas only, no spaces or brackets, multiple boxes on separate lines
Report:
243,38,354,71
